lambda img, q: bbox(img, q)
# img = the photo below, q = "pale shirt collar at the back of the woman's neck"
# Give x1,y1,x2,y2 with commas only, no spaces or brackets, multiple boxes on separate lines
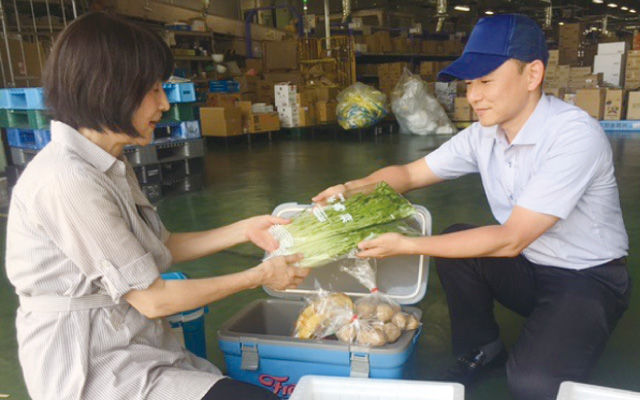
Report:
51,121,118,172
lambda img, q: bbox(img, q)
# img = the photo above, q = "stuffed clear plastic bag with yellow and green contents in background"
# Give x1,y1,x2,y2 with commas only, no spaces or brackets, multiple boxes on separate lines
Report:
336,82,389,130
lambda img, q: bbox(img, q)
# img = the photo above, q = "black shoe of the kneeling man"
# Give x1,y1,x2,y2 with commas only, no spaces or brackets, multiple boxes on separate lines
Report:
438,349,507,386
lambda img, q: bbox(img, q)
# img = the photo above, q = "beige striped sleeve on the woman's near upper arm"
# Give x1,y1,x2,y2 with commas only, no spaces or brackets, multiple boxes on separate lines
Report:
31,172,160,302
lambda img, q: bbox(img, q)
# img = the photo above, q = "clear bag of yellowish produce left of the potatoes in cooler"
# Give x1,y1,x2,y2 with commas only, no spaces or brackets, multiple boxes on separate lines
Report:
293,290,354,339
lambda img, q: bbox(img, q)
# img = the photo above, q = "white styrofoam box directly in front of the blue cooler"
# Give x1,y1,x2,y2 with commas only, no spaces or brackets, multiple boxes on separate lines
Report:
289,375,464,400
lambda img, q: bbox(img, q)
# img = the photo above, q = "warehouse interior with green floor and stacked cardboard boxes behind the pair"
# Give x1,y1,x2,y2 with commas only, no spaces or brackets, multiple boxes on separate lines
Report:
0,0,640,400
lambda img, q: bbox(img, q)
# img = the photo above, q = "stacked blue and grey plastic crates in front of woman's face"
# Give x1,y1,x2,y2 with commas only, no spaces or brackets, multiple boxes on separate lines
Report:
124,83,204,201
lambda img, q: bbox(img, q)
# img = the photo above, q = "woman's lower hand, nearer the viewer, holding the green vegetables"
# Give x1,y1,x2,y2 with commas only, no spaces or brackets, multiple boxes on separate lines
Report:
255,254,311,290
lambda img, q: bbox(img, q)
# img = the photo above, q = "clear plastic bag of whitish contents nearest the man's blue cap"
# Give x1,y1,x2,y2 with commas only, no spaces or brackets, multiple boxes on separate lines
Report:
391,68,456,135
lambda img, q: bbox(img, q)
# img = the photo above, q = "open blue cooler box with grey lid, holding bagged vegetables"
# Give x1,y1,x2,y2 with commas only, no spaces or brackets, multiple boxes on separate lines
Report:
218,203,431,399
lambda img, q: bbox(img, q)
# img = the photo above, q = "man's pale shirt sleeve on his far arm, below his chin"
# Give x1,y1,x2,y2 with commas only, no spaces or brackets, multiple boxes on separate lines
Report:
425,125,479,179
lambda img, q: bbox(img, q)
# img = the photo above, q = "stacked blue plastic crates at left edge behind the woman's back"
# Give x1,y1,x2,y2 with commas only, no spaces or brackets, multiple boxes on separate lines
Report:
0,88,51,185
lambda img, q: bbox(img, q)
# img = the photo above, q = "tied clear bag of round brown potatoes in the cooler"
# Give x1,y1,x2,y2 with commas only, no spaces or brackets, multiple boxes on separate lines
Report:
340,259,420,336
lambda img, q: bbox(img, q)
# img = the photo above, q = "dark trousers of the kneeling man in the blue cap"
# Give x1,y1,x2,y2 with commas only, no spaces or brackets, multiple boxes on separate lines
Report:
436,224,631,400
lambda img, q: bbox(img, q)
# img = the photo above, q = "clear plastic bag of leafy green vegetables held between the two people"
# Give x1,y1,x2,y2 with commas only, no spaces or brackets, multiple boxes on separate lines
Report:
267,182,420,267
